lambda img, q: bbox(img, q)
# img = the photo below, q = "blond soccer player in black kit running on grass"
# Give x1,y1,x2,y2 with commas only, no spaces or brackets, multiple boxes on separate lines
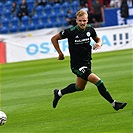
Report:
51,10,127,110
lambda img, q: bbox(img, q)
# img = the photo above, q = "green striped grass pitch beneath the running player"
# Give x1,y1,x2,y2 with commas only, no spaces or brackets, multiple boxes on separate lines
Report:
0,49,133,133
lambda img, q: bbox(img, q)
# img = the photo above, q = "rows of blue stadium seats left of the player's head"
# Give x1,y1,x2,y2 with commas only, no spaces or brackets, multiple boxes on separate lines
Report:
0,0,79,34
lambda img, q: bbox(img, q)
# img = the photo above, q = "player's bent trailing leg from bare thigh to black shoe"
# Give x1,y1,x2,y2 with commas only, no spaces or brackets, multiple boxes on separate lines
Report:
53,77,87,108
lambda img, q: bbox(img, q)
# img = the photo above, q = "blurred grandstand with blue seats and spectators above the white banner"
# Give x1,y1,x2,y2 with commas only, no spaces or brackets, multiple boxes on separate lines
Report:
0,0,133,34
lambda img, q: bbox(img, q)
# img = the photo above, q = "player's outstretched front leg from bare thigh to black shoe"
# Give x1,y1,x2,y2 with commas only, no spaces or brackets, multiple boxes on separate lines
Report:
88,73,127,110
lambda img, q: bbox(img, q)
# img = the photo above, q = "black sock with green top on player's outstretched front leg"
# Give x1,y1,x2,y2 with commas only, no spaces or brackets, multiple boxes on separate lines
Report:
96,80,114,103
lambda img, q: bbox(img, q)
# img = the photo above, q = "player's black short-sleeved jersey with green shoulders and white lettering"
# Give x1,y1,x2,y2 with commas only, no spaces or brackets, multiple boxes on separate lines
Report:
60,25,97,68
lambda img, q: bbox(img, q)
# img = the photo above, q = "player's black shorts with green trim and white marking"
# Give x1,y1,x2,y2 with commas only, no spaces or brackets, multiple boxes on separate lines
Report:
71,64,92,81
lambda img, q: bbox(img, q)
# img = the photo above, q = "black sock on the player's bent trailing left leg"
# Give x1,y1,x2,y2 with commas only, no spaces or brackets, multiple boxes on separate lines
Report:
61,84,80,95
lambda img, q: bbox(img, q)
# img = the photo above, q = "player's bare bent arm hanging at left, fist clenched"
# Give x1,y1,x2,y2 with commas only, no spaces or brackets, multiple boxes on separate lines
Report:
51,33,64,60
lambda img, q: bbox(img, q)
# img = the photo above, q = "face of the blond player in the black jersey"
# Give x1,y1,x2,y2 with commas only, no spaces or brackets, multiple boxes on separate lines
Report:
76,15,88,30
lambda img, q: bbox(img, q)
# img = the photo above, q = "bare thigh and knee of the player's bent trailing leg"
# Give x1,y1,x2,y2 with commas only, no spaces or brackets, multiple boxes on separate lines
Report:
76,77,87,90
